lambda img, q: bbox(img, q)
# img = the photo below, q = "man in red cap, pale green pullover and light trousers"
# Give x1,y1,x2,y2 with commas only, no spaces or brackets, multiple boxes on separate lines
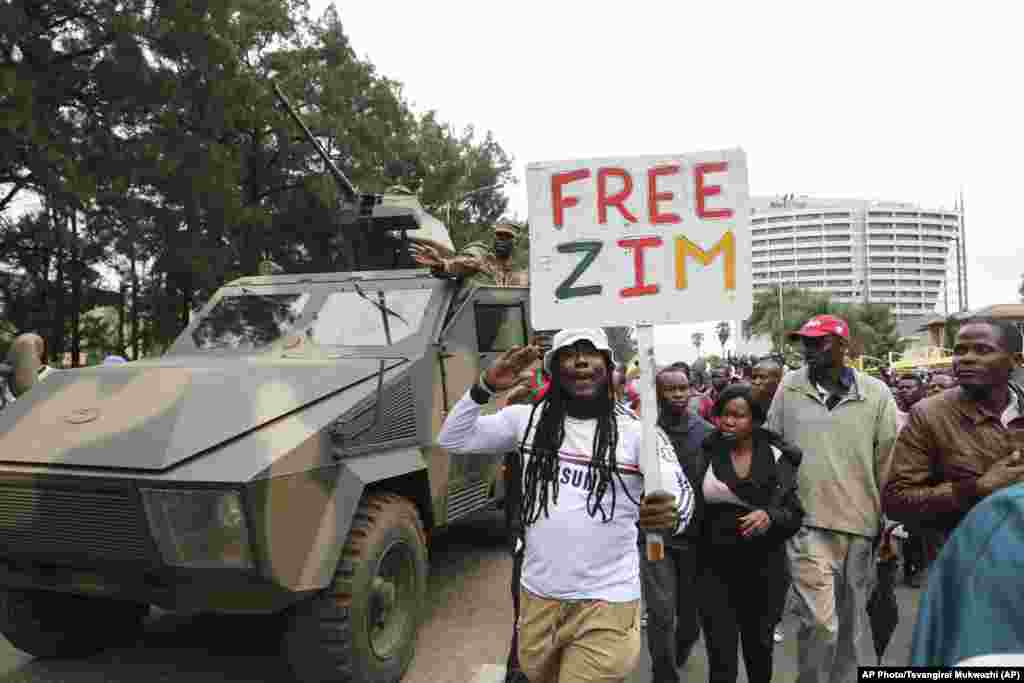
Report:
765,315,898,683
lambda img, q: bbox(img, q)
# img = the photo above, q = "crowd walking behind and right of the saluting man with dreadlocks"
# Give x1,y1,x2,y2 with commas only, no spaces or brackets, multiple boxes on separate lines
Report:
468,315,1024,683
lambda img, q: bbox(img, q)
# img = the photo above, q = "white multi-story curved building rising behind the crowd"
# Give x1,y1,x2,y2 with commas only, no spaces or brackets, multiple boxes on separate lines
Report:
751,196,967,319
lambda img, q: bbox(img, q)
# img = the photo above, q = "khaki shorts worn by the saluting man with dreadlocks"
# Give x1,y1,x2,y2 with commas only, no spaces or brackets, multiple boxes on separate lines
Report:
516,591,640,683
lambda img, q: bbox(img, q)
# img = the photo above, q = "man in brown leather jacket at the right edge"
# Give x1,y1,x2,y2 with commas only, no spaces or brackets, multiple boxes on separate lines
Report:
882,318,1024,540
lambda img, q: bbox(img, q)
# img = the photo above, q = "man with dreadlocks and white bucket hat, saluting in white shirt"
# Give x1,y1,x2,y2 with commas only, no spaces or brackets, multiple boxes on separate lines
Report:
438,329,693,683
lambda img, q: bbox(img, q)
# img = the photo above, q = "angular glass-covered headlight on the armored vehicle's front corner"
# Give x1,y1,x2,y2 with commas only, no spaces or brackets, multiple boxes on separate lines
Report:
140,488,253,568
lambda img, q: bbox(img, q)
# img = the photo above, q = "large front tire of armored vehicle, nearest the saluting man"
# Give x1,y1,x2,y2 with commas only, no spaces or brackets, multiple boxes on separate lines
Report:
284,494,428,683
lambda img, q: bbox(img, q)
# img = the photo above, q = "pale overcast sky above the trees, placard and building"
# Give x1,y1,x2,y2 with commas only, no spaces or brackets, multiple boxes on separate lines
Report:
311,0,1024,360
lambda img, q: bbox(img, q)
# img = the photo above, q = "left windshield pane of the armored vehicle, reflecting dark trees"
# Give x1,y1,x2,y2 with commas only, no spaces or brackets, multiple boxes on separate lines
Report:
191,294,310,351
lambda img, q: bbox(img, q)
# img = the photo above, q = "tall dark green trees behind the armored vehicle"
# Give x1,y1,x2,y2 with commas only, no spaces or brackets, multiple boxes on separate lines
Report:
0,0,512,355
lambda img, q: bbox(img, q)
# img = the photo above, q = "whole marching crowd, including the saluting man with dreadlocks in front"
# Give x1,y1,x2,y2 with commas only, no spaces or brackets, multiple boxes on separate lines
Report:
440,315,1024,683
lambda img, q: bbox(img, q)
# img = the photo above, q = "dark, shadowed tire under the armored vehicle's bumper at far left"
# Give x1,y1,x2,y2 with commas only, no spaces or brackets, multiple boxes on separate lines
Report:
0,591,150,658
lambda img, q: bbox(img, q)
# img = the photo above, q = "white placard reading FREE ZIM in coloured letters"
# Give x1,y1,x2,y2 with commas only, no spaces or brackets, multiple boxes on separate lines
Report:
526,148,754,330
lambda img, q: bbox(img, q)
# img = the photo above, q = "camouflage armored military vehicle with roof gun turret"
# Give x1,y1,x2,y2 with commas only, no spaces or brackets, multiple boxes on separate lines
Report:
0,82,529,682
